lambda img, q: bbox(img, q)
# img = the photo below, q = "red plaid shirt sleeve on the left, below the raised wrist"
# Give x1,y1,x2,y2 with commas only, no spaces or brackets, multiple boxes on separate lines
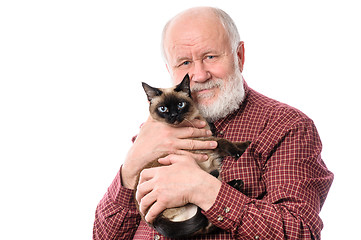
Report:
93,171,140,240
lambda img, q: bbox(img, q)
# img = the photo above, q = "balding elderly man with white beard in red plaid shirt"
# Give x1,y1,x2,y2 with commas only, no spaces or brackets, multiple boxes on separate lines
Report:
93,7,333,239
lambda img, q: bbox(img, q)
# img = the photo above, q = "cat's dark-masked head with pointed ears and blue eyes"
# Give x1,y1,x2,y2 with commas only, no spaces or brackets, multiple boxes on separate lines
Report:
142,74,198,125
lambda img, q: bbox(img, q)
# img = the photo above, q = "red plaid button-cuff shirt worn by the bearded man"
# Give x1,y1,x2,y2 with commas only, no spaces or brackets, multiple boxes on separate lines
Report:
93,84,333,240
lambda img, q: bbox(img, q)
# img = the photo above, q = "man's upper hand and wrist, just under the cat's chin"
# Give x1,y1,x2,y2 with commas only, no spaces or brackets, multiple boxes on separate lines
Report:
122,117,217,189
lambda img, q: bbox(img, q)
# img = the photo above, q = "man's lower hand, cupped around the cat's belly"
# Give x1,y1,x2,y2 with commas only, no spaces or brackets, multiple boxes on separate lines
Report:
136,154,221,222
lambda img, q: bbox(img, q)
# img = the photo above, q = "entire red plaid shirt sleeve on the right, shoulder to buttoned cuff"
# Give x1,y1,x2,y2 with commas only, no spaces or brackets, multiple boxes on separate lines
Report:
204,116,333,239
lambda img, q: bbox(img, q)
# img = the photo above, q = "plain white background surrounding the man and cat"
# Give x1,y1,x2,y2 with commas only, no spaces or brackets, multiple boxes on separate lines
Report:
0,0,361,240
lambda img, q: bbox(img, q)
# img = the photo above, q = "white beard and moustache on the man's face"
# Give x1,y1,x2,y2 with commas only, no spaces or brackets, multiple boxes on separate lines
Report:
191,68,245,122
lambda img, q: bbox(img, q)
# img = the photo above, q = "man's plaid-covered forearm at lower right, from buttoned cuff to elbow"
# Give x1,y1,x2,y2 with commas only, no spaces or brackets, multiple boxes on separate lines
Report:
203,179,328,239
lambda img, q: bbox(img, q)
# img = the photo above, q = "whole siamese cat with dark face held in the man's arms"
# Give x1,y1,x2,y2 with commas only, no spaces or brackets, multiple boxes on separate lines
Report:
135,74,250,238
